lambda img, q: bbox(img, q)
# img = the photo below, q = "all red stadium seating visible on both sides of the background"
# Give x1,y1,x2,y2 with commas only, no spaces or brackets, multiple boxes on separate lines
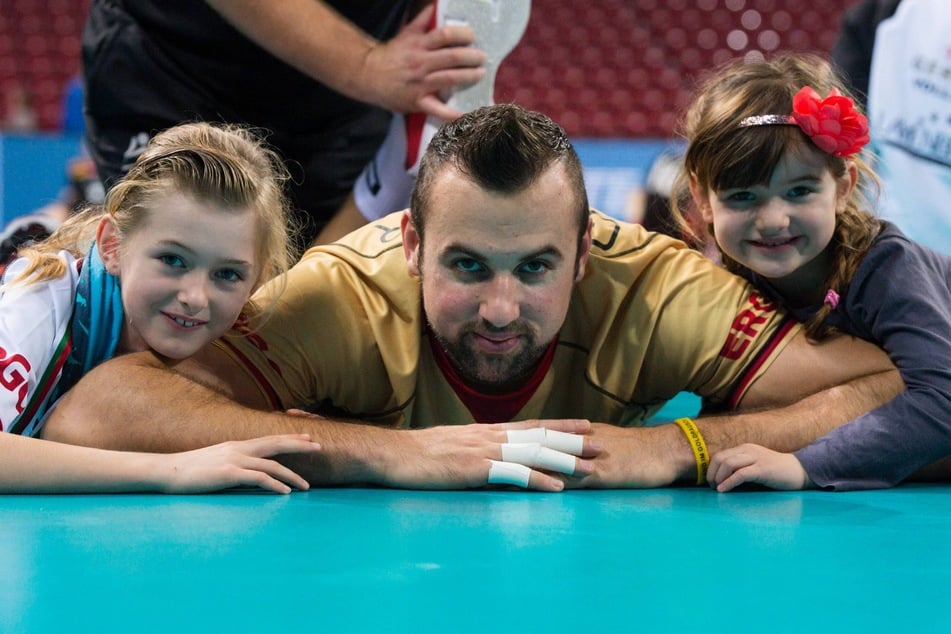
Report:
7,0,854,137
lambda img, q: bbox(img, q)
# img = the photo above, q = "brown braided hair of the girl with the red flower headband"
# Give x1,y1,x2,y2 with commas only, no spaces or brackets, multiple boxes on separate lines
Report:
671,54,881,340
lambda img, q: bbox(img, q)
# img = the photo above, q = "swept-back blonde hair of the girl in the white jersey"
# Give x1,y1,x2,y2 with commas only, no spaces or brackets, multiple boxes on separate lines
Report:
14,122,295,324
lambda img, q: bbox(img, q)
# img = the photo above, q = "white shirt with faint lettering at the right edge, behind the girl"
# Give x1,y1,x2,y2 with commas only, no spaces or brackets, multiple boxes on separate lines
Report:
868,0,951,254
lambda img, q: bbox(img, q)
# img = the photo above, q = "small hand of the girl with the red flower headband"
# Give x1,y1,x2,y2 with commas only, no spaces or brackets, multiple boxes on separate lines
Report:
707,443,812,493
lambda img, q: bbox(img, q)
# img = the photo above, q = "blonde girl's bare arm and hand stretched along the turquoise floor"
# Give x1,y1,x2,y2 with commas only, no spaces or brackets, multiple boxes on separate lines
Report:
0,434,320,493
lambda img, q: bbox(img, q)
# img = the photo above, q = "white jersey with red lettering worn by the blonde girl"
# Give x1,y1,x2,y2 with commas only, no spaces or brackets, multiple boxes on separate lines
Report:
0,251,79,436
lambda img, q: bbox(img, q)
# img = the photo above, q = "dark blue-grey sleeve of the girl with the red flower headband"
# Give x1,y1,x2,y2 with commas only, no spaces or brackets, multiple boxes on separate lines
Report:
796,234,951,490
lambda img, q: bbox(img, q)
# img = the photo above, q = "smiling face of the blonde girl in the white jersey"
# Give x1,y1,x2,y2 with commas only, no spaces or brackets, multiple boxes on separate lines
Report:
101,192,258,359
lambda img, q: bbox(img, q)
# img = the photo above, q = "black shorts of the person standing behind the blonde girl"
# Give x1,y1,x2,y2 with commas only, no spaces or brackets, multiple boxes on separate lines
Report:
83,1,390,245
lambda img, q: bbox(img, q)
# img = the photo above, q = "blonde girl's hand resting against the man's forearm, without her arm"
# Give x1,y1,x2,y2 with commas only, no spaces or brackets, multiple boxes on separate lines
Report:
157,434,320,493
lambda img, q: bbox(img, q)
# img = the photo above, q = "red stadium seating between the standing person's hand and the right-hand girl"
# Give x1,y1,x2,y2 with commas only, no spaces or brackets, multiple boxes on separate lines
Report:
496,0,854,137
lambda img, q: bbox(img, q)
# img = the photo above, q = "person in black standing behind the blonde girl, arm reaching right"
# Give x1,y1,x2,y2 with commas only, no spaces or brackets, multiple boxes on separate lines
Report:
83,0,485,252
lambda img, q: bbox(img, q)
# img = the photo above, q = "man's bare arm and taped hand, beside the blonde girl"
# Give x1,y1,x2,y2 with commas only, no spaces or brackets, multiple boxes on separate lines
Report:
44,354,599,491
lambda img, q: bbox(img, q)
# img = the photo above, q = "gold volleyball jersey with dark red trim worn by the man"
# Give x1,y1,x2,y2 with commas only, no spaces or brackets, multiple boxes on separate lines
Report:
219,212,798,427
